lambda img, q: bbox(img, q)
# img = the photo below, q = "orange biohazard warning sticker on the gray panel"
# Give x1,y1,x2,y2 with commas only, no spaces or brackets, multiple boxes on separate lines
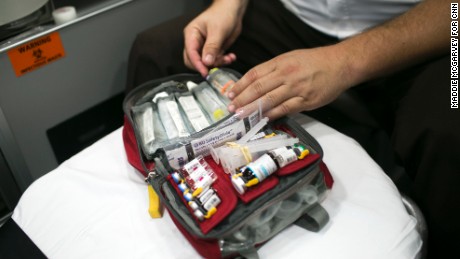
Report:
8,32,65,77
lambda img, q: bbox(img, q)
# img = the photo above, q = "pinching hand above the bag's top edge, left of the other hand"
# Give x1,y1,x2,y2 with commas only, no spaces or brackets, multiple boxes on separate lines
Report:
184,0,248,77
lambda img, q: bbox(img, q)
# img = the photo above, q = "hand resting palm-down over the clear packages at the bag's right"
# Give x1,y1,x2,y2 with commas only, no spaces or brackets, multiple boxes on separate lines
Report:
228,46,352,119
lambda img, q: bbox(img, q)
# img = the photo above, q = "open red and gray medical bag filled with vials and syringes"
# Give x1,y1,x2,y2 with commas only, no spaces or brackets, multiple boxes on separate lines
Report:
123,70,333,258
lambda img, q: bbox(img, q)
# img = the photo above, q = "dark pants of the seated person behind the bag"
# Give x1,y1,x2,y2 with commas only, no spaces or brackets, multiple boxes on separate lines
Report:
127,0,460,258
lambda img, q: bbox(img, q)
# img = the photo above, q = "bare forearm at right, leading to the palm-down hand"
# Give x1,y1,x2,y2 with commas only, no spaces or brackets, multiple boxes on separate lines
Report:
334,0,450,86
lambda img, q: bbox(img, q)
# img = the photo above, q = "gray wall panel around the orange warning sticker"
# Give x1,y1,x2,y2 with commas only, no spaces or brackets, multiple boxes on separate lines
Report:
0,0,202,187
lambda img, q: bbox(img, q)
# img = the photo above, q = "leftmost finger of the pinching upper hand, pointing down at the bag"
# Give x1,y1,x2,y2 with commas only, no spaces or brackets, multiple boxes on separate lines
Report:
184,28,208,76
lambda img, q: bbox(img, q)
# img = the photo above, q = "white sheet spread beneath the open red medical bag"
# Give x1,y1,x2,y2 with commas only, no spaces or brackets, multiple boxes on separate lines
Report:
13,114,422,259
